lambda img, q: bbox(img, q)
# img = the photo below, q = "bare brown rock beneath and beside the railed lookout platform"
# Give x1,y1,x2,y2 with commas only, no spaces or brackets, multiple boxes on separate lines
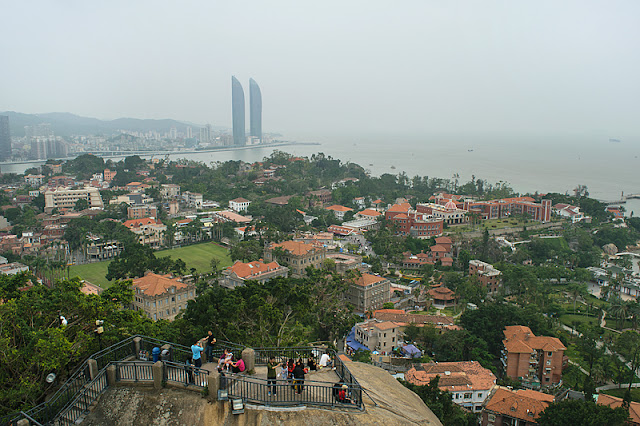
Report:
82,363,441,426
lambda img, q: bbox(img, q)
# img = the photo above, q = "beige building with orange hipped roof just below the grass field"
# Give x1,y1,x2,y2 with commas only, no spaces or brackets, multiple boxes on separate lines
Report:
132,272,196,321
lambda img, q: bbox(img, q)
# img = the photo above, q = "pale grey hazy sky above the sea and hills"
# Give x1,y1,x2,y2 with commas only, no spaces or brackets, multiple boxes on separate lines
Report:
0,0,640,137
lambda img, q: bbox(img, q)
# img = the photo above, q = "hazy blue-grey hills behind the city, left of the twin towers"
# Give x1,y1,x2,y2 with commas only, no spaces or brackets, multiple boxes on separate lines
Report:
0,111,224,137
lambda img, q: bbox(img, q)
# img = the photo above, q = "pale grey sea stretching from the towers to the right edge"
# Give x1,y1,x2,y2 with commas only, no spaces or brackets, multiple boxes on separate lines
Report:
174,134,640,202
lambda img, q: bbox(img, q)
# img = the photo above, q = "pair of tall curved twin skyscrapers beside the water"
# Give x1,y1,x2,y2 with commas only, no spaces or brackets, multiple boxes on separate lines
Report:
231,76,262,146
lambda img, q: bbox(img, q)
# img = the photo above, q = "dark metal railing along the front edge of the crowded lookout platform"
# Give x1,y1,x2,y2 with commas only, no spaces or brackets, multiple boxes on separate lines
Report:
220,374,364,410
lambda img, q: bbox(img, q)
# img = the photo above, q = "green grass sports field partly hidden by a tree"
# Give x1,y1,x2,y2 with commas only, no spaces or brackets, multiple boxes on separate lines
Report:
69,243,231,288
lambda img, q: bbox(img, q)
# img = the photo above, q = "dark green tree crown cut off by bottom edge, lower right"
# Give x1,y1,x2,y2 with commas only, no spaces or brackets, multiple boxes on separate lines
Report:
537,399,629,426
